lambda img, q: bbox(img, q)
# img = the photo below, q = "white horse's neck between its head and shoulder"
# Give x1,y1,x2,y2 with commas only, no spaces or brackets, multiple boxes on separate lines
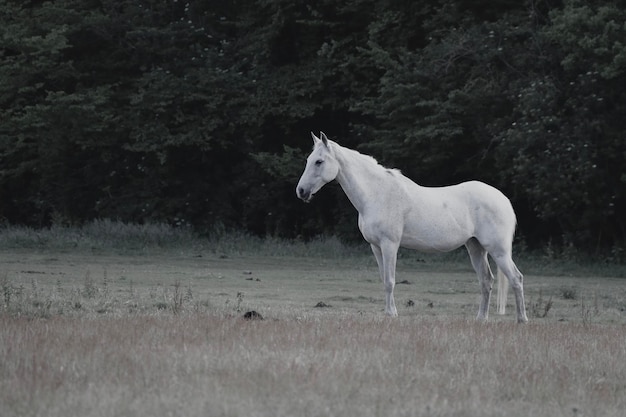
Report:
333,143,384,212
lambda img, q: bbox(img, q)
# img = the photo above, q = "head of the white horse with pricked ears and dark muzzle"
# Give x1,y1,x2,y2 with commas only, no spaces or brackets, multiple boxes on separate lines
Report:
296,132,339,203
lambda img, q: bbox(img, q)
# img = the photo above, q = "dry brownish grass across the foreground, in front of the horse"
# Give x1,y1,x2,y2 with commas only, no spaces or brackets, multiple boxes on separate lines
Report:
0,314,626,417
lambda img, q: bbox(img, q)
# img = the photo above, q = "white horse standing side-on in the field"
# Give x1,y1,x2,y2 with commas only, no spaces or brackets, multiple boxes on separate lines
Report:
296,133,528,323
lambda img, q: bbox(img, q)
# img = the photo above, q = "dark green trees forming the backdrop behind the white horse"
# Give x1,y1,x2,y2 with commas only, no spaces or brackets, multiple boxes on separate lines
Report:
0,0,626,258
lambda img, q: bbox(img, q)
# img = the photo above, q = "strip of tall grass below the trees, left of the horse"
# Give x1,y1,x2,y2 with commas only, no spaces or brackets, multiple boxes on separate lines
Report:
0,219,369,258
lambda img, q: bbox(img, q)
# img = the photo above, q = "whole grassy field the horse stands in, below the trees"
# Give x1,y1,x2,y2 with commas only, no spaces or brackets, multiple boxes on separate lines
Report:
0,225,626,417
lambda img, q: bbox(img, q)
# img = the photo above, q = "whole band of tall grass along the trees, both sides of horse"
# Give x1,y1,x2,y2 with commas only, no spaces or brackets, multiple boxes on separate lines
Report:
0,219,626,277
